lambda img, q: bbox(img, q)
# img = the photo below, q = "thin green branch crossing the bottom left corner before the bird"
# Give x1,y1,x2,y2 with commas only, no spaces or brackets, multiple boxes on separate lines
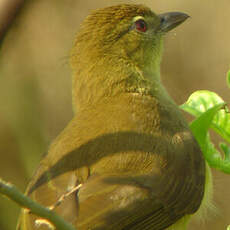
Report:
0,178,76,230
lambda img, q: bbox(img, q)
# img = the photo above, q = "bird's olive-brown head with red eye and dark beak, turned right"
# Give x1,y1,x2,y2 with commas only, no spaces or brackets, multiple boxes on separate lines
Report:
71,4,188,110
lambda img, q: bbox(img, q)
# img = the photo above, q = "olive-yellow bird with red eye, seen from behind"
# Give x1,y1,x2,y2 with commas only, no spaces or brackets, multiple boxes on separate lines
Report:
18,4,212,230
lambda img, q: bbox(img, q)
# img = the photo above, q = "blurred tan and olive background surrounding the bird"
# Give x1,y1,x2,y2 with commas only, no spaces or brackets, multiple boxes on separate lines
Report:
0,0,230,230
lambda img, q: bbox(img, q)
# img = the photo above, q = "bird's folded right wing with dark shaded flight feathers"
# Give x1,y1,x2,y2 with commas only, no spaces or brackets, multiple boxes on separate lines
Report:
75,131,205,230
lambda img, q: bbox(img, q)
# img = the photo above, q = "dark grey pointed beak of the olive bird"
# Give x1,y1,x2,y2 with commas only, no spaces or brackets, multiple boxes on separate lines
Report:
158,12,189,32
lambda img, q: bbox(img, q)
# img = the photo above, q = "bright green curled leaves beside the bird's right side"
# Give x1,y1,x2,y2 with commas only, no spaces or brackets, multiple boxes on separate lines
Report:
181,78,230,174
